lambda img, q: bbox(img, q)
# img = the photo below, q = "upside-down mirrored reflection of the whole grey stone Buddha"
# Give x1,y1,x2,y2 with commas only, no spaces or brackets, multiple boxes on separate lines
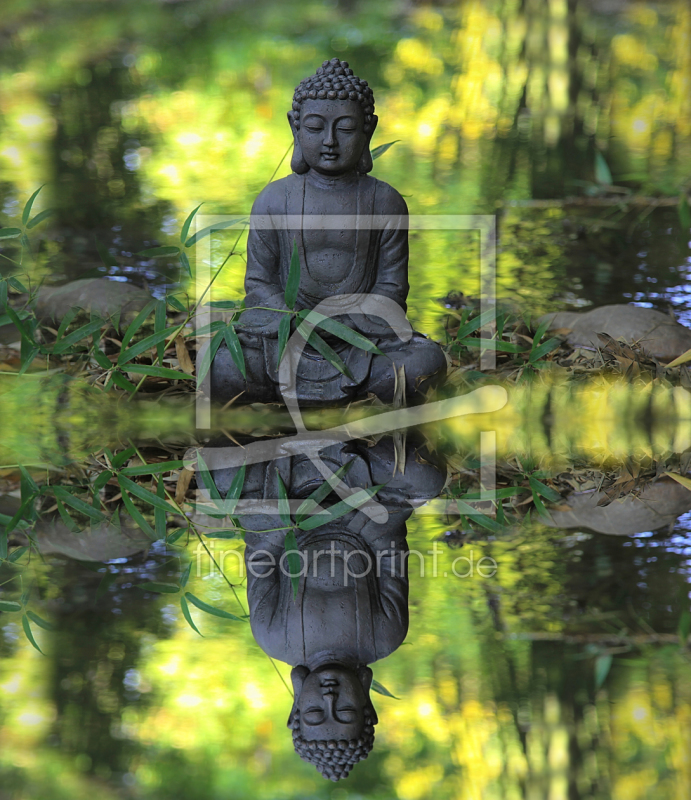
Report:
198,439,445,781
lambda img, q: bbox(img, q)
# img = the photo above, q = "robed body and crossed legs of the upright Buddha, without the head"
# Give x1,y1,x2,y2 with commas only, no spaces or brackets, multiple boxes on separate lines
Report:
209,171,446,405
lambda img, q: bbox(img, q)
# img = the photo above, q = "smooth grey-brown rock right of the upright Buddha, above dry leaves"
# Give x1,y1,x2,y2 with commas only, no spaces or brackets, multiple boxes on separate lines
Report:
540,305,691,361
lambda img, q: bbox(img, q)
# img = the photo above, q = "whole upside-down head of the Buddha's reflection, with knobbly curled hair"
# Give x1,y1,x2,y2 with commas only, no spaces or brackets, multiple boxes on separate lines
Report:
288,664,379,781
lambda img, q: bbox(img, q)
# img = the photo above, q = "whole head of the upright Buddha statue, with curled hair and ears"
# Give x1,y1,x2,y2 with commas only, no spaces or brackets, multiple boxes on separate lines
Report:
288,58,377,177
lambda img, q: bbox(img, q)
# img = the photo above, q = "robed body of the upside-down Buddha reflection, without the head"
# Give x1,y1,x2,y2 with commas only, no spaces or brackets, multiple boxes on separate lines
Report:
203,440,445,669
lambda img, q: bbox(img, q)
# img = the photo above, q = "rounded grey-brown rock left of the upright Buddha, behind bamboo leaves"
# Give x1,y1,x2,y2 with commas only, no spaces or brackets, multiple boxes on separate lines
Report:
36,278,151,322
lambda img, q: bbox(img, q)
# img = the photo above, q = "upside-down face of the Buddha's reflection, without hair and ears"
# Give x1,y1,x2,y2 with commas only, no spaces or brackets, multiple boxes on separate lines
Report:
298,665,367,741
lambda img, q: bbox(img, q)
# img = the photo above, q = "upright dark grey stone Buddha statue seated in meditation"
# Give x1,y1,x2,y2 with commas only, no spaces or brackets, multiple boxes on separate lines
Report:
208,58,446,406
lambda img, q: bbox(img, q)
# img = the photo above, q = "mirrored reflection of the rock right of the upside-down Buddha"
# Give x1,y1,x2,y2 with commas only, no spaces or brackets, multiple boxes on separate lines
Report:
545,478,691,536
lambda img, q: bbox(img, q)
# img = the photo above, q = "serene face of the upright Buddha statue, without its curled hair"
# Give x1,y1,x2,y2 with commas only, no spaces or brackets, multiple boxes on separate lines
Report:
297,100,371,176
